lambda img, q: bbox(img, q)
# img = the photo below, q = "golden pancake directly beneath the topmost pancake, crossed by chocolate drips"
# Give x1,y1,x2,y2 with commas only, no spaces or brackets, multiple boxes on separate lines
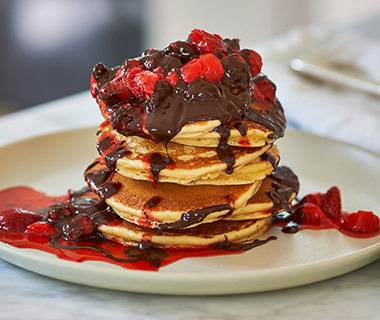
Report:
98,124,279,185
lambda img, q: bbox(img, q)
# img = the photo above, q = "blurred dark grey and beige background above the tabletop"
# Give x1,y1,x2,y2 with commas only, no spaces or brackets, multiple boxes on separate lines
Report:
0,0,380,115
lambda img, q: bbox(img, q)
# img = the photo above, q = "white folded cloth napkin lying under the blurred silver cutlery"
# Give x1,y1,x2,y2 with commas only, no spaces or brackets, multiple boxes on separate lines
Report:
254,27,380,154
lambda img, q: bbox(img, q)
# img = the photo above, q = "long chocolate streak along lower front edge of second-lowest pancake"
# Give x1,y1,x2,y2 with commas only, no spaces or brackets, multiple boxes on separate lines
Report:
157,204,232,234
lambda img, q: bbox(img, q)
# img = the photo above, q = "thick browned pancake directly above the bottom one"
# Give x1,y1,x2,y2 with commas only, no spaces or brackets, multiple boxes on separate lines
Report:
86,162,261,229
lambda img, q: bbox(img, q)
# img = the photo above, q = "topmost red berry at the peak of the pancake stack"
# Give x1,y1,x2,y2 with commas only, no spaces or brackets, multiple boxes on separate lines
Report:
189,29,227,55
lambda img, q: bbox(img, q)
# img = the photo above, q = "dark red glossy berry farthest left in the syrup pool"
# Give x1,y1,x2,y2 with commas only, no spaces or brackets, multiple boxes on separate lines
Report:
0,208,42,234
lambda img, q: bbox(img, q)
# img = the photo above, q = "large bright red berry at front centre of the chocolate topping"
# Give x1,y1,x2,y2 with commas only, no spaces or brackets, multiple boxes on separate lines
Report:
181,53,224,83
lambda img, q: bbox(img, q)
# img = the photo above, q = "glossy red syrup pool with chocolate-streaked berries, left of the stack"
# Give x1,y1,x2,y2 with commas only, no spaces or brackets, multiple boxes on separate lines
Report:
0,186,276,271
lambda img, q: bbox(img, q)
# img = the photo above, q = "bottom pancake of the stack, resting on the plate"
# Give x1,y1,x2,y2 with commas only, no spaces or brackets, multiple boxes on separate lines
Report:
98,218,270,247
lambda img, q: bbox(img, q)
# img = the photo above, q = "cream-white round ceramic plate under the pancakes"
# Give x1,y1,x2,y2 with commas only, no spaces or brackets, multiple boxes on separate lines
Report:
0,128,380,295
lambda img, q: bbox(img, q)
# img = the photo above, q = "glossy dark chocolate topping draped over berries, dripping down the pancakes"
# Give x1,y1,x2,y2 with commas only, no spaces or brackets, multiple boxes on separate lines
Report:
92,30,286,173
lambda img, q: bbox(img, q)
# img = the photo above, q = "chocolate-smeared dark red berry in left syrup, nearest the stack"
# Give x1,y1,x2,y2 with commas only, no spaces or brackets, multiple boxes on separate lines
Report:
62,213,95,241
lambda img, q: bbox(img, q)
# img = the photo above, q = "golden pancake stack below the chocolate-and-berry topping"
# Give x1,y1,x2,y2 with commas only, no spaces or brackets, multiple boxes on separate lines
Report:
86,117,296,247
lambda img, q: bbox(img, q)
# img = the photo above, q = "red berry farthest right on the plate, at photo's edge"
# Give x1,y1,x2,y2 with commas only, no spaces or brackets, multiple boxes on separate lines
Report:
342,210,380,232
